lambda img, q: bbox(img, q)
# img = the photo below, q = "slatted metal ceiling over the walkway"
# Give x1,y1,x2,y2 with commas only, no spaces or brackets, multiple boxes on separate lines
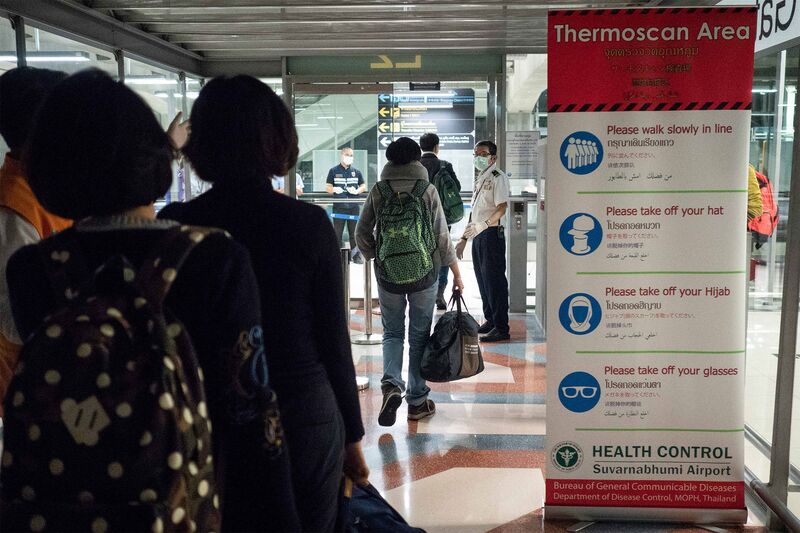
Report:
75,0,716,61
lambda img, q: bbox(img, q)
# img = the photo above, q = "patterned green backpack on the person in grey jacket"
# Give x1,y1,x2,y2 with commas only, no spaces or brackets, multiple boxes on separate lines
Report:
376,180,436,294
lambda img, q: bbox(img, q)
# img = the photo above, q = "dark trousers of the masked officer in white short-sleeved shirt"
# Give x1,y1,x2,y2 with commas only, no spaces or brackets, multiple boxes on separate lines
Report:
472,226,508,333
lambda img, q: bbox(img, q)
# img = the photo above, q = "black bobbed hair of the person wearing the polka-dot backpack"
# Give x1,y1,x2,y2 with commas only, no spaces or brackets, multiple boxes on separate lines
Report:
25,69,173,219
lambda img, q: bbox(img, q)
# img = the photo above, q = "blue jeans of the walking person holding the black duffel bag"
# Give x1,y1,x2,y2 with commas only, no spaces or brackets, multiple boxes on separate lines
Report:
378,283,436,406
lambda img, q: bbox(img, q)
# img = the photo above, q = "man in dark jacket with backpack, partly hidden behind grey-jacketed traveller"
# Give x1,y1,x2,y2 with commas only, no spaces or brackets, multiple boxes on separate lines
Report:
419,133,464,309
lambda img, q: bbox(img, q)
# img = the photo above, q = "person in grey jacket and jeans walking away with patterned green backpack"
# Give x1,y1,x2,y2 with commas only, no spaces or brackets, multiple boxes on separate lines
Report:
356,137,464,426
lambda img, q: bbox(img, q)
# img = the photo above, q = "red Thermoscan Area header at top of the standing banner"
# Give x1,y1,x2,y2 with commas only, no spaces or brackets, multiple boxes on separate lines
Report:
547,7,756,112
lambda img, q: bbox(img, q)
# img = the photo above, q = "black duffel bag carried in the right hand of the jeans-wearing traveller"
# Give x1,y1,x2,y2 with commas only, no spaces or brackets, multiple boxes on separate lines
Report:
420,290,483,382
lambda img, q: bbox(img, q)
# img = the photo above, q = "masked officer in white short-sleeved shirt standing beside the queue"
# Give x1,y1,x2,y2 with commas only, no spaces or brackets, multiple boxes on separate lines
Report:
456,141,511,342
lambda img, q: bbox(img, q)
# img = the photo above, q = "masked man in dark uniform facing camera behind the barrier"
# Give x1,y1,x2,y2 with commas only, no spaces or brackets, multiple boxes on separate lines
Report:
325,147,367,263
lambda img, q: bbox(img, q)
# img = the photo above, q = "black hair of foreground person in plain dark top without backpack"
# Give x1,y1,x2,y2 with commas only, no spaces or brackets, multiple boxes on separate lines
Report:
183,75,298,185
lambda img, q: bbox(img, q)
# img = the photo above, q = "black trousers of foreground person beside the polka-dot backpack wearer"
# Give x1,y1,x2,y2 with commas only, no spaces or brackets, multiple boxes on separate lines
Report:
278,383,344,533
